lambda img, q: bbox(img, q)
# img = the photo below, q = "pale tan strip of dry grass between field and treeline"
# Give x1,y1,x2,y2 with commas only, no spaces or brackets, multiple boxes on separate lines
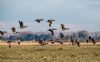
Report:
0,41,100,45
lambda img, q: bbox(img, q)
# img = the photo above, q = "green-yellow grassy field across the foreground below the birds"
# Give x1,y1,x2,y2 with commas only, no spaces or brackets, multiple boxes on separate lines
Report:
0,45,100,62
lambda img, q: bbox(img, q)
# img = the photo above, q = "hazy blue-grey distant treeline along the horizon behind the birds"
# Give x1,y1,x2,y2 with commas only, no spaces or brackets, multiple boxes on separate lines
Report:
0,31,100,41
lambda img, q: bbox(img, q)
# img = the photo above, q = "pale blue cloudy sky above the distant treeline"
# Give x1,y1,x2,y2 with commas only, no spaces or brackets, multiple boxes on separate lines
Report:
0,0,100,32
